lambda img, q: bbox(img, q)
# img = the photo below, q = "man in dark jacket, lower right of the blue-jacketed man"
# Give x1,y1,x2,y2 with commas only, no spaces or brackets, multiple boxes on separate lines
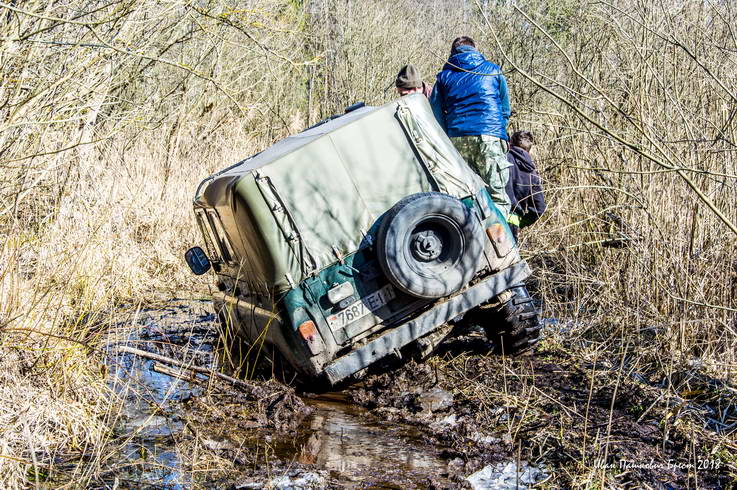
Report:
507,131,546,240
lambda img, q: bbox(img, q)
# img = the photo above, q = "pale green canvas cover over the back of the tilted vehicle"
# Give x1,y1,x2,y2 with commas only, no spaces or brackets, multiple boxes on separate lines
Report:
197,94,484,289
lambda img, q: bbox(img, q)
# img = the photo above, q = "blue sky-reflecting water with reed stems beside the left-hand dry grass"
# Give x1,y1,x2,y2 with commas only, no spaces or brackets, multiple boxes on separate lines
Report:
106,302,217,489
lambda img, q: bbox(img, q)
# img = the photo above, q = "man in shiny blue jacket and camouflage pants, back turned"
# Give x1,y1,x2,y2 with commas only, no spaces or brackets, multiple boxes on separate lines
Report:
430,36,510,217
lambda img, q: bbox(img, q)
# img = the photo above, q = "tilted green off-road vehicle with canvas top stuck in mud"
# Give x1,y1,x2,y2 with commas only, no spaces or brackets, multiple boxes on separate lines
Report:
186,94,540,383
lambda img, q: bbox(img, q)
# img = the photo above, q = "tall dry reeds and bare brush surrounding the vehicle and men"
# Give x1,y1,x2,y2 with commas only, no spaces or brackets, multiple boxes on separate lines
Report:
0,0,737,486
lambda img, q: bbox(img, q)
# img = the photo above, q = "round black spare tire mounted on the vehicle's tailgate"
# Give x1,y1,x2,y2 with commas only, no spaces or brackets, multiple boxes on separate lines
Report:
376,192,484,299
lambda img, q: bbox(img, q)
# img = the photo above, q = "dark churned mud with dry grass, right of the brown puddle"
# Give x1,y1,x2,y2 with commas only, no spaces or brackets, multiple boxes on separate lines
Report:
348,337,737,488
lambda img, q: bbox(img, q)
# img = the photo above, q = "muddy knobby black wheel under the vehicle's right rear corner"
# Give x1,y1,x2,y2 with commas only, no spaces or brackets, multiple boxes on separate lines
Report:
481,286,542,354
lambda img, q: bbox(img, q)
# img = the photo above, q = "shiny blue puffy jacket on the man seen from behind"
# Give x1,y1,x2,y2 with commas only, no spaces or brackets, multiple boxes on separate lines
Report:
430,46,510,140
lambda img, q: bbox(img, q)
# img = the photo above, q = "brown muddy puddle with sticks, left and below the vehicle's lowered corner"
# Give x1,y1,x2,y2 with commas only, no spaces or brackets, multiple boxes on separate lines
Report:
100,301,457,488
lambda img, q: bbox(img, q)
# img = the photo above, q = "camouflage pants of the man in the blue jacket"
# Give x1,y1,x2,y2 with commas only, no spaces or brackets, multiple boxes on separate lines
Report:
451,134,512,216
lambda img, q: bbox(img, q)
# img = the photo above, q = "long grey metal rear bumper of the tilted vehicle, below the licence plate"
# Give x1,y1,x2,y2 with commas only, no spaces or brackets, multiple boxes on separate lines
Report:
324,260,530,384
